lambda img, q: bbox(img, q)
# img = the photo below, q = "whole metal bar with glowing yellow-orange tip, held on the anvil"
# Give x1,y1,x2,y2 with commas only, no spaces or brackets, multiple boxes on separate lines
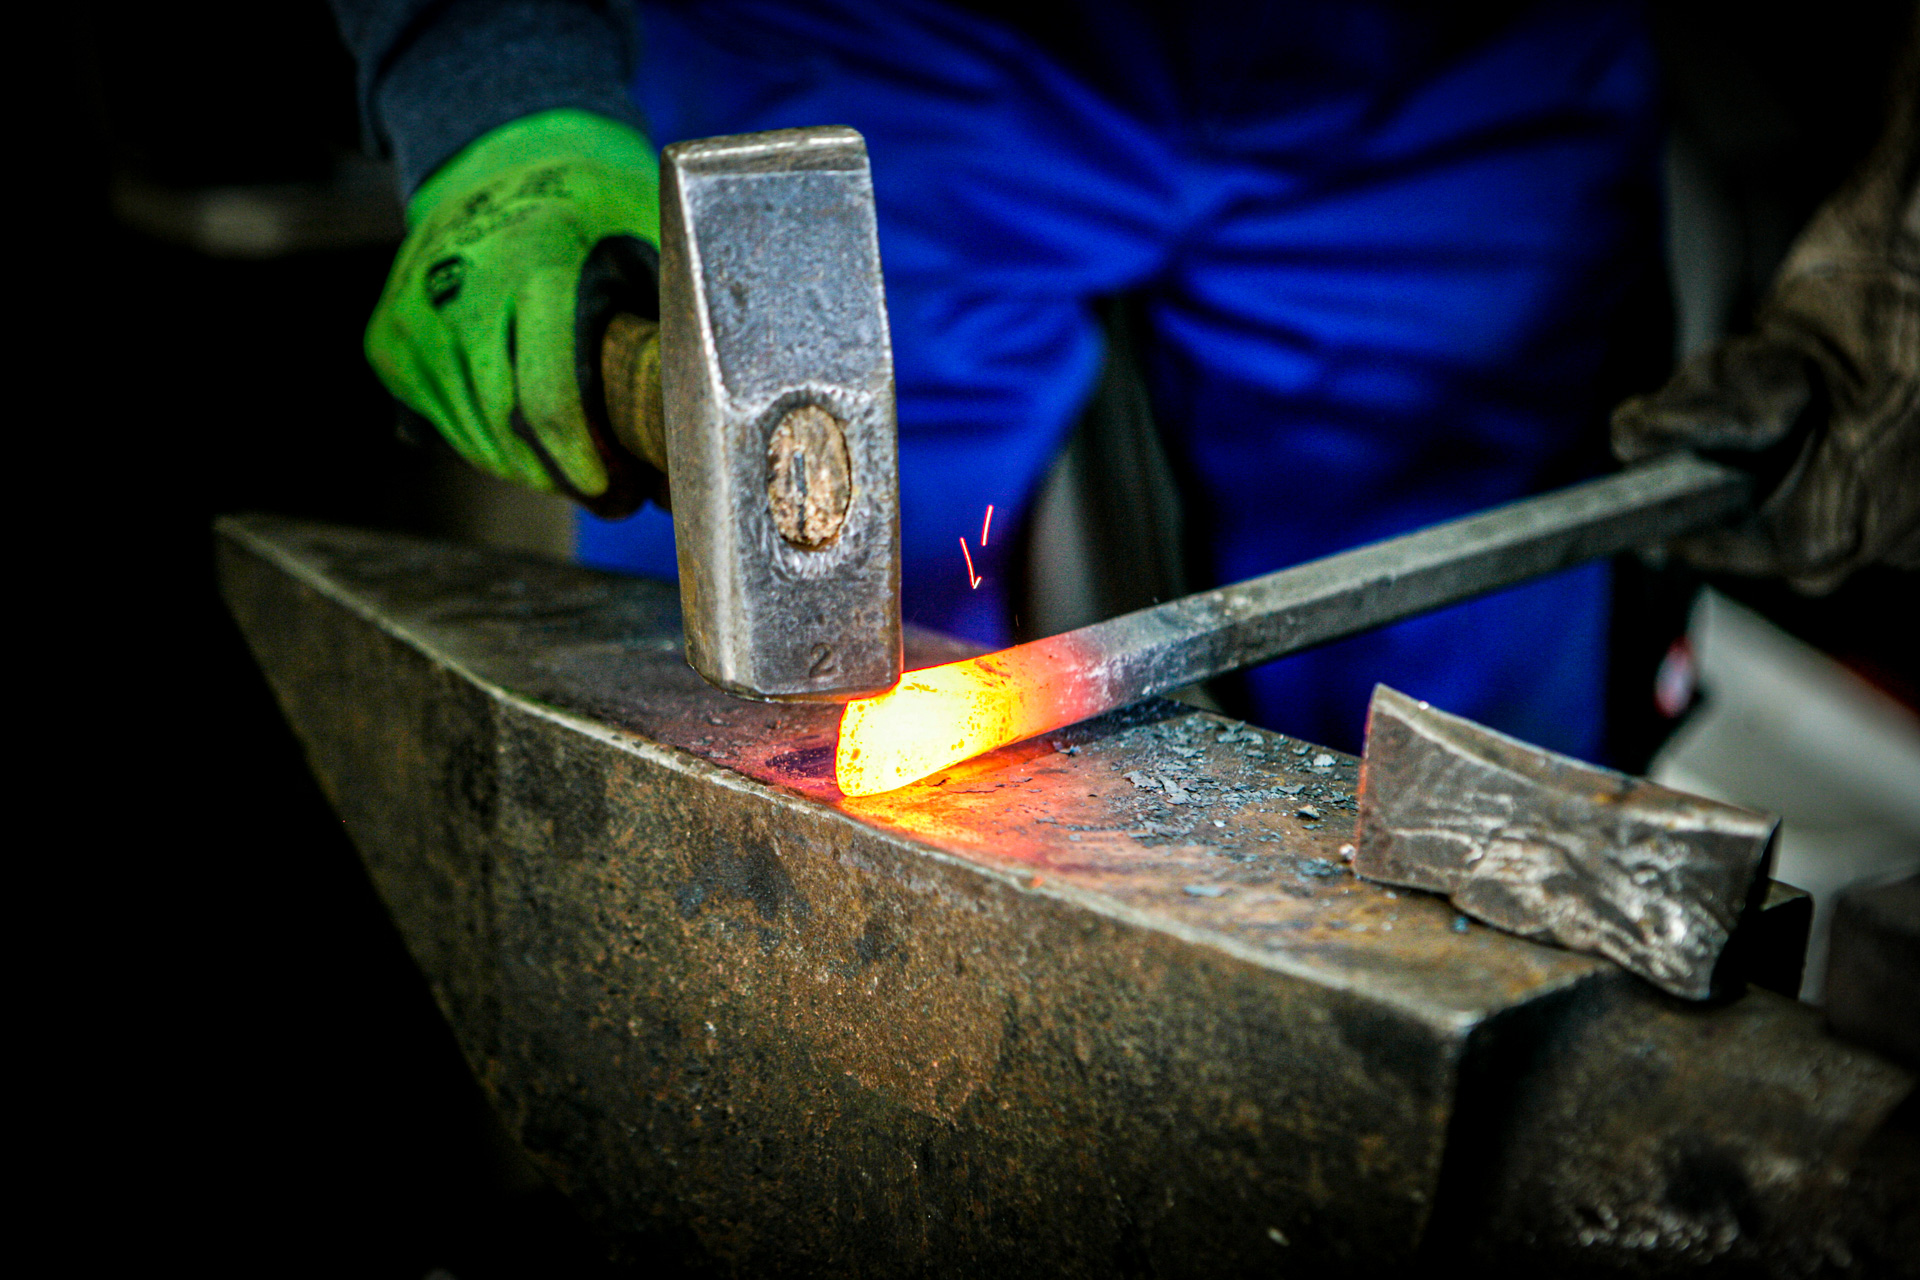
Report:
835,455,1751,794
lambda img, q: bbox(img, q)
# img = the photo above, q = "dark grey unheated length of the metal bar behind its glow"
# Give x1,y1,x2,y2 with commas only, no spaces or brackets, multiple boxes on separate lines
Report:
1067,455,1751,708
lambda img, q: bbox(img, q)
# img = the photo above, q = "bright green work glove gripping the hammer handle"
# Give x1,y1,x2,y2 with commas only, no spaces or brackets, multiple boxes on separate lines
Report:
367,111,660,516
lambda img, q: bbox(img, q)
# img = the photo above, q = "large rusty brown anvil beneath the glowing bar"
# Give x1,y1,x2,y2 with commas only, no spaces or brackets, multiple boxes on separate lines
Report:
219,516,1914,1274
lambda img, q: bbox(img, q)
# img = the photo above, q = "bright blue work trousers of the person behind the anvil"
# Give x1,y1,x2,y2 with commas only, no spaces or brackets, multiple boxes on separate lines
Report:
578,0,1659,756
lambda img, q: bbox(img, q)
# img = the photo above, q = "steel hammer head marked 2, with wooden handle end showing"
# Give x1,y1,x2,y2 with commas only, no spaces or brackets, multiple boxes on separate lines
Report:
660,127,900,702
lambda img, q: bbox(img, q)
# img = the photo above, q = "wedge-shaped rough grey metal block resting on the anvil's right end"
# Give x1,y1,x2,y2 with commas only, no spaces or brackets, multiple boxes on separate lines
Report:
1354,685,1780,1000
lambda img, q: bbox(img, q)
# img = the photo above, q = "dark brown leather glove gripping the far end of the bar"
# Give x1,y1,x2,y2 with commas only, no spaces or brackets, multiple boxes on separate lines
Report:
1613,38,1920,593
